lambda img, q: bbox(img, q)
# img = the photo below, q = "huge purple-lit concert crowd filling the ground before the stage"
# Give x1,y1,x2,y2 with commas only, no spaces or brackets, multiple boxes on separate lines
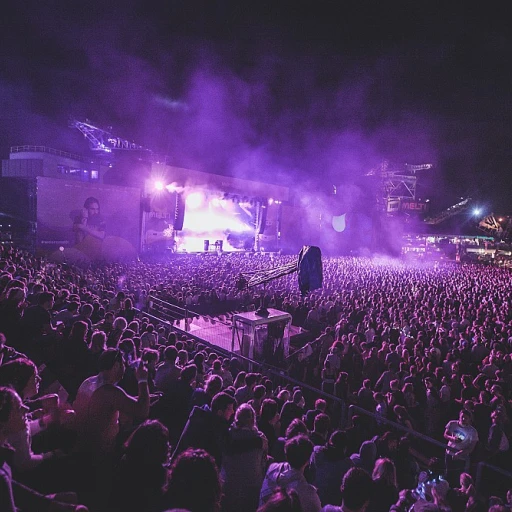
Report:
0,246,512,512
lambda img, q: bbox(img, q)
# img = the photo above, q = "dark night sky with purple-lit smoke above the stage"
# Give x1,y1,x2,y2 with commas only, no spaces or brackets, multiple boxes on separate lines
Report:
0,0,512,214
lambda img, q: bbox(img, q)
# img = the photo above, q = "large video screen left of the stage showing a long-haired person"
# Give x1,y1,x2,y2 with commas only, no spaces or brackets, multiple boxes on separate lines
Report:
37,177,141,263
